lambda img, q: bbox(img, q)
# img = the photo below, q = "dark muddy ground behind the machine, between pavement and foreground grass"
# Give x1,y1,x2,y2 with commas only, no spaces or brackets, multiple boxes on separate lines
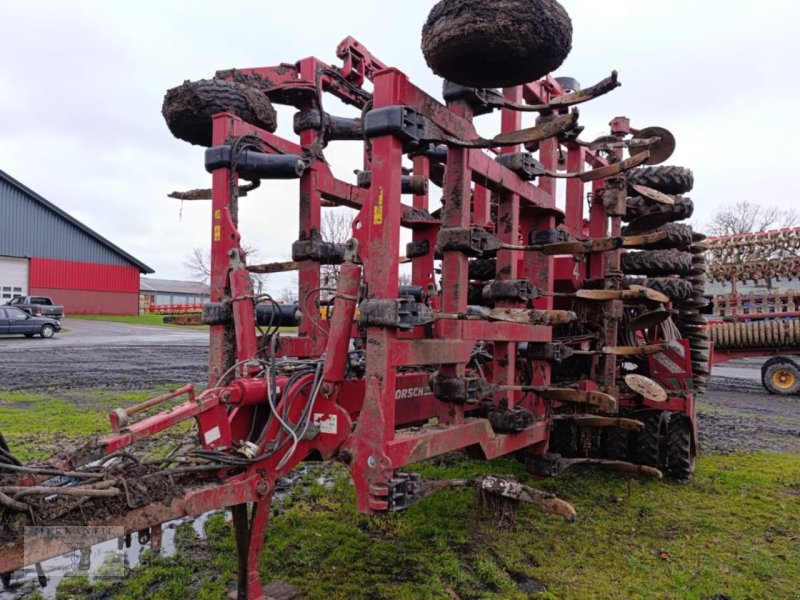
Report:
0,334,800,453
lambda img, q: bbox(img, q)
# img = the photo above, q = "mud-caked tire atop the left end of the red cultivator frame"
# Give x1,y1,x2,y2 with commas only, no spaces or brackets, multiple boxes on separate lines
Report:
161,79,278,146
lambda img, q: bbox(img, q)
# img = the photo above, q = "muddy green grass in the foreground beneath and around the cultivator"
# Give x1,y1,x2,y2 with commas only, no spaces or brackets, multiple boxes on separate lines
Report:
0,390,800,600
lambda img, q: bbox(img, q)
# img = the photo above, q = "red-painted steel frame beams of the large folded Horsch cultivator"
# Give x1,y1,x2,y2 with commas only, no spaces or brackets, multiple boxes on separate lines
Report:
0,38,694,600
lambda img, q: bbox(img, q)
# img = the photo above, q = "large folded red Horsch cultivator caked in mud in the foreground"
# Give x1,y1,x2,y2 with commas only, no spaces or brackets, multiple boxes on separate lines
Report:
0,5,709,599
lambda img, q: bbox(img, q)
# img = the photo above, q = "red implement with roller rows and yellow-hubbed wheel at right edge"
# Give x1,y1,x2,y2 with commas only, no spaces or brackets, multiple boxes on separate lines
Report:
707,227,800,395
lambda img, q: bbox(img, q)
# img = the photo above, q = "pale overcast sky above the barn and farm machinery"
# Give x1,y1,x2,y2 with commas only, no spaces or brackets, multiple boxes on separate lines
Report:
0,0,800,289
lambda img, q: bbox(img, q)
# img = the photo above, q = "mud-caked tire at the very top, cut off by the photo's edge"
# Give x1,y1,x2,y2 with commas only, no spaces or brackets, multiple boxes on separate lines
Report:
422,0,572,88
